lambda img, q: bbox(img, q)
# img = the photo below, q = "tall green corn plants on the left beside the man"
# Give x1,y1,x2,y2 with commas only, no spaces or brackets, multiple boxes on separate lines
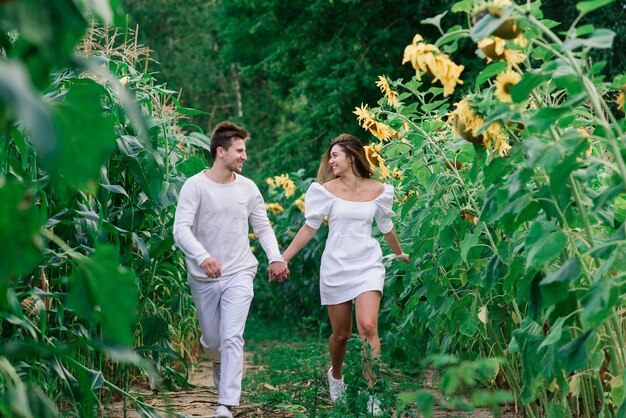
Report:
0,0,207,417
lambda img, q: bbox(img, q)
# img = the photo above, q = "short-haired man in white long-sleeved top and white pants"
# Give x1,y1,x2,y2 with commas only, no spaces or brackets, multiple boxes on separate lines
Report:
174,122,289,417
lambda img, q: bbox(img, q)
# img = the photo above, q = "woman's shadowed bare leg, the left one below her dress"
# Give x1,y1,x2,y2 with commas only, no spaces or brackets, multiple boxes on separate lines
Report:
327,301,352,379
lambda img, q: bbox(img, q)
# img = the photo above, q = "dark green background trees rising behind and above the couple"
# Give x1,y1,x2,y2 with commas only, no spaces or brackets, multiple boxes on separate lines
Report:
125,0,626,180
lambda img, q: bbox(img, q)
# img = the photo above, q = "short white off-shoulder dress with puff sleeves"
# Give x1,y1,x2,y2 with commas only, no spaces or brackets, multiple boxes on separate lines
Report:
304,183,394,305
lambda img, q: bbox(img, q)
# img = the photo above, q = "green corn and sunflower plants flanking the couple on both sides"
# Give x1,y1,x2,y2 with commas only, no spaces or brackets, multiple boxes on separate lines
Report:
0,0,626,418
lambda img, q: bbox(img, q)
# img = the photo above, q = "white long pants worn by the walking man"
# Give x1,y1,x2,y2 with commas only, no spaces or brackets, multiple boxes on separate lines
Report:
187,270,256,406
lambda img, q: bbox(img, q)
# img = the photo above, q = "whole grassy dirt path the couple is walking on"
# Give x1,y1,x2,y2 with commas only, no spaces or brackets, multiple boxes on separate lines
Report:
105,317,517,418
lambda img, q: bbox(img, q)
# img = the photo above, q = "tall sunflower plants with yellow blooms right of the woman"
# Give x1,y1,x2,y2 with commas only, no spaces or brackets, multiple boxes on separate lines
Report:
348,0,626,417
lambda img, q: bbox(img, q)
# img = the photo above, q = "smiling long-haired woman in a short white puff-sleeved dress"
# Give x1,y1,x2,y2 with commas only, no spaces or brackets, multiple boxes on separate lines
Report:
283,134,409,416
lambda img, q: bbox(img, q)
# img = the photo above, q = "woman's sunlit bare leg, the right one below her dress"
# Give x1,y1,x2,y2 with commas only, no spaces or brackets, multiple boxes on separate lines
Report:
355,291,382,387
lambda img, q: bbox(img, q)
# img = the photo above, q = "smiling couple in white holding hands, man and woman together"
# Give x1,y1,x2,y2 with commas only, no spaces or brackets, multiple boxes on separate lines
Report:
174,122,409,417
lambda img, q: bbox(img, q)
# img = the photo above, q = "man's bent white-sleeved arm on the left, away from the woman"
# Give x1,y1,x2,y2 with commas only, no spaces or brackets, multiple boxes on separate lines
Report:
174,181,211,266
